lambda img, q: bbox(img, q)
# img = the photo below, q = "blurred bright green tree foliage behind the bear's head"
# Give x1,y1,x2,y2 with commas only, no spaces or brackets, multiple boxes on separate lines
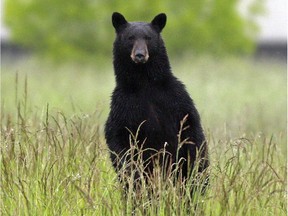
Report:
5,0,259,61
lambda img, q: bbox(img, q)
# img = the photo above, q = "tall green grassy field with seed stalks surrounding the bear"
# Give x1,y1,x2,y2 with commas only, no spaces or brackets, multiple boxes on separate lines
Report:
0,57,287,216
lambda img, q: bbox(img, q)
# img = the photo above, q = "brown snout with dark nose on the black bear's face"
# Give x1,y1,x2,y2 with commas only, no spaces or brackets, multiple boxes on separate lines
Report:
131,41,149,64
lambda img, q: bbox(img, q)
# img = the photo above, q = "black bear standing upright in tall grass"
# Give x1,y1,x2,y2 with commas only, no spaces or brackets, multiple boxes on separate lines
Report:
105,12,209,191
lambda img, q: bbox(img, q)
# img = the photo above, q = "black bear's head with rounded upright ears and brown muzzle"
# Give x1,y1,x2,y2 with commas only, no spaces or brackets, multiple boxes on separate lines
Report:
112,12,167,64
